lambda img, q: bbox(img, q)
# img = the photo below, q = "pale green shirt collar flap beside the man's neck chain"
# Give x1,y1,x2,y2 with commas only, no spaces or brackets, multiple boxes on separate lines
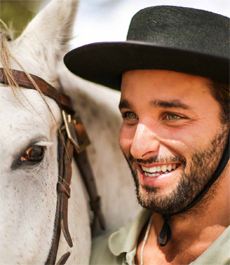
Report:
108,209,152,256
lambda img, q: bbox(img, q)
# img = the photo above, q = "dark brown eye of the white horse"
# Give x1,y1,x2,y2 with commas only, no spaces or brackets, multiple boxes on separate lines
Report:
20,145,46,162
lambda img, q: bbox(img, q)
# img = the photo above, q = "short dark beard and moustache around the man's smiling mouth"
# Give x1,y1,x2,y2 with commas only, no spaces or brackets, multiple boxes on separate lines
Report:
126,128,229,215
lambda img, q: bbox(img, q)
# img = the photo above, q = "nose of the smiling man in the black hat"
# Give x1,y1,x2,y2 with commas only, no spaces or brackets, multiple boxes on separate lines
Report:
130,123,160,159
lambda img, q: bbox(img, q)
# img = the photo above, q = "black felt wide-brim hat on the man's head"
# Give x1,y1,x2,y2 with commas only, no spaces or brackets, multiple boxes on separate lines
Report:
64,6,230,90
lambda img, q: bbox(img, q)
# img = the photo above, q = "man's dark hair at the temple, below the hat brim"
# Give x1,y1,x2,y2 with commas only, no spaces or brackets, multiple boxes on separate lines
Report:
209,80,230,125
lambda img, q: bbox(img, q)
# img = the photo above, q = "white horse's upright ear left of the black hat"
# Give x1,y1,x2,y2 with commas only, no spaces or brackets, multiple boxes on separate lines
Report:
15,0,78,66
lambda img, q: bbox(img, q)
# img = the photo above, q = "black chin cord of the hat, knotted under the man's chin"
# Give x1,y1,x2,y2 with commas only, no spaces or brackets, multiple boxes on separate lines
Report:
158,134,230,247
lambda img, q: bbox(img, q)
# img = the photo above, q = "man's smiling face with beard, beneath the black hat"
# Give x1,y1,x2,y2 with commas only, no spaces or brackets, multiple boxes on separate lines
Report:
119,70,228,214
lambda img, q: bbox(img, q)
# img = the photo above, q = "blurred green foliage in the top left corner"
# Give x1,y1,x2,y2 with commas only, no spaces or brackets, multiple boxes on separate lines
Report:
0,0,42,37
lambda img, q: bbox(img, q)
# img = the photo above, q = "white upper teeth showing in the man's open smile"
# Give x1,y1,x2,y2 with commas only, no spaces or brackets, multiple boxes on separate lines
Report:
141,163,180,177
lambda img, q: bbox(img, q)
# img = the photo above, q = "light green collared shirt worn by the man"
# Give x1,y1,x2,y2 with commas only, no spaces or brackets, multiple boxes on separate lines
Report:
90,210,230,265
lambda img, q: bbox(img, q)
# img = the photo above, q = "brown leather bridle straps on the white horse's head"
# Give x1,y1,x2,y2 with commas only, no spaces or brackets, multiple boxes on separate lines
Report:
0,68,105,265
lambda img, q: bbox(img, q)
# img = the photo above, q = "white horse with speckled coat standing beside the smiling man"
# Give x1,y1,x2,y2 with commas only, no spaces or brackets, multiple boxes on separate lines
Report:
0,0,139,264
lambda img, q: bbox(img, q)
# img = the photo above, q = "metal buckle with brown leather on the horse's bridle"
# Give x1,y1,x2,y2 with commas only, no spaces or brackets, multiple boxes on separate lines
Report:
62,110,90,153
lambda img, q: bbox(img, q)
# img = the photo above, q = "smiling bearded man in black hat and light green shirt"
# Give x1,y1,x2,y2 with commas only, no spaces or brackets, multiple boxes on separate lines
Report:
65,6,230,265
